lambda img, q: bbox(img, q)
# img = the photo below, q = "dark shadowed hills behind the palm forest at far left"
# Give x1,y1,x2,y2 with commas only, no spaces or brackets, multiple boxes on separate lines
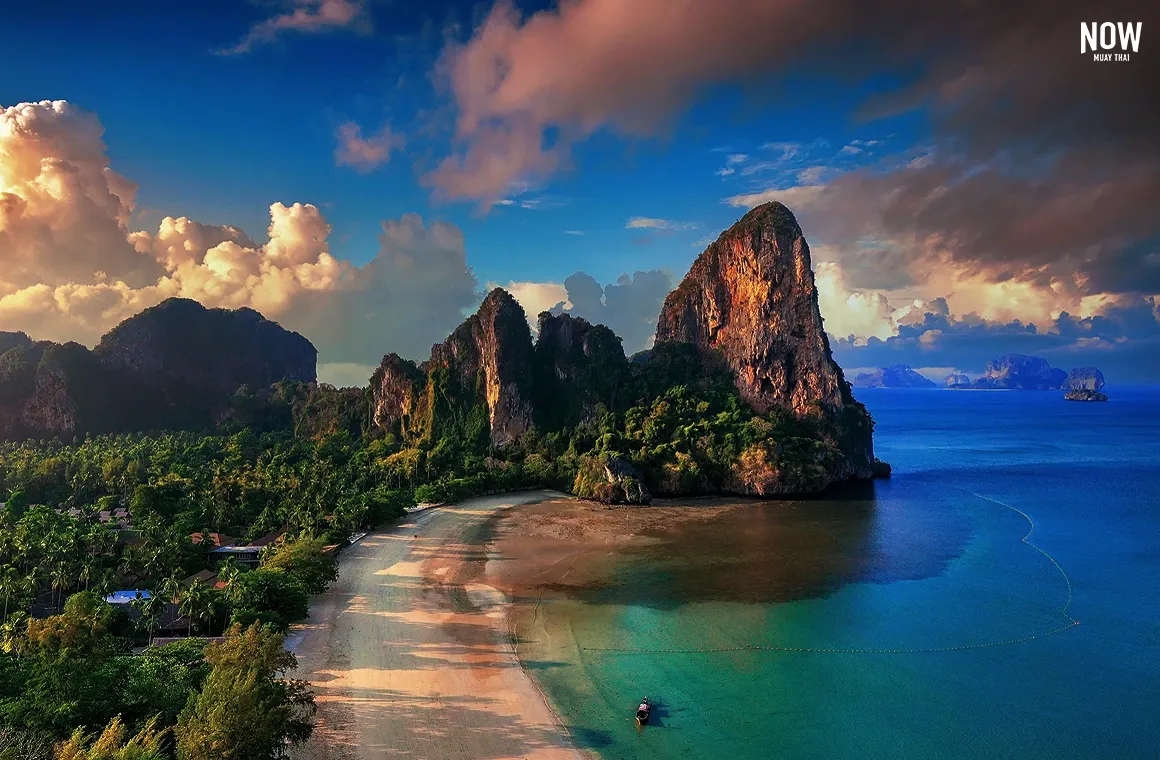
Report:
0,299,317,439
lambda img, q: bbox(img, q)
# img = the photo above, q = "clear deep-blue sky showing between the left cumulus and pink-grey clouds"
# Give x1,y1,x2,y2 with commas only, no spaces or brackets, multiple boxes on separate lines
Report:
0,1,904,282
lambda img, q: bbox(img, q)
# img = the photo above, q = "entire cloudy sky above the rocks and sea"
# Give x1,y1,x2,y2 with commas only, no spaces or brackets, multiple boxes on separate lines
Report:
0,0,1160,384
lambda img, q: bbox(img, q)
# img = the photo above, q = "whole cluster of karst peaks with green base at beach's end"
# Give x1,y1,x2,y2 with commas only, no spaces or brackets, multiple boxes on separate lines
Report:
371,203,876,495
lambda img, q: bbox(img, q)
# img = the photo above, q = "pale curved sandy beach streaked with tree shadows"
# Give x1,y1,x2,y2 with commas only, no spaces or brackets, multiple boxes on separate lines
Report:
289,492,582,760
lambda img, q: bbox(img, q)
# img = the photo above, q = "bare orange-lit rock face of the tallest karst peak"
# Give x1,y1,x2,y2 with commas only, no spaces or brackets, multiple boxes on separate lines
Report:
657,202,873,477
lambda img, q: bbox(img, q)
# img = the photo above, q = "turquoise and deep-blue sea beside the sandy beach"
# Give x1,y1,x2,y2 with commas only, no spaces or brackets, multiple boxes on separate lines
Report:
522,388,1160,760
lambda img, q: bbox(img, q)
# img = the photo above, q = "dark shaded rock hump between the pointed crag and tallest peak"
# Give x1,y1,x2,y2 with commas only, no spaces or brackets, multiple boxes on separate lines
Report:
535,311,629,430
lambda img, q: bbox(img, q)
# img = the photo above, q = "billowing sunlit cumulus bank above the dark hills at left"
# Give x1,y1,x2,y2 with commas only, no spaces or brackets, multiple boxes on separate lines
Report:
0,101,477,378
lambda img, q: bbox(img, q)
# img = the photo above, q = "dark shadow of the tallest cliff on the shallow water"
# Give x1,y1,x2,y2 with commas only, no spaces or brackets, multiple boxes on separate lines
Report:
553,482,971,609
